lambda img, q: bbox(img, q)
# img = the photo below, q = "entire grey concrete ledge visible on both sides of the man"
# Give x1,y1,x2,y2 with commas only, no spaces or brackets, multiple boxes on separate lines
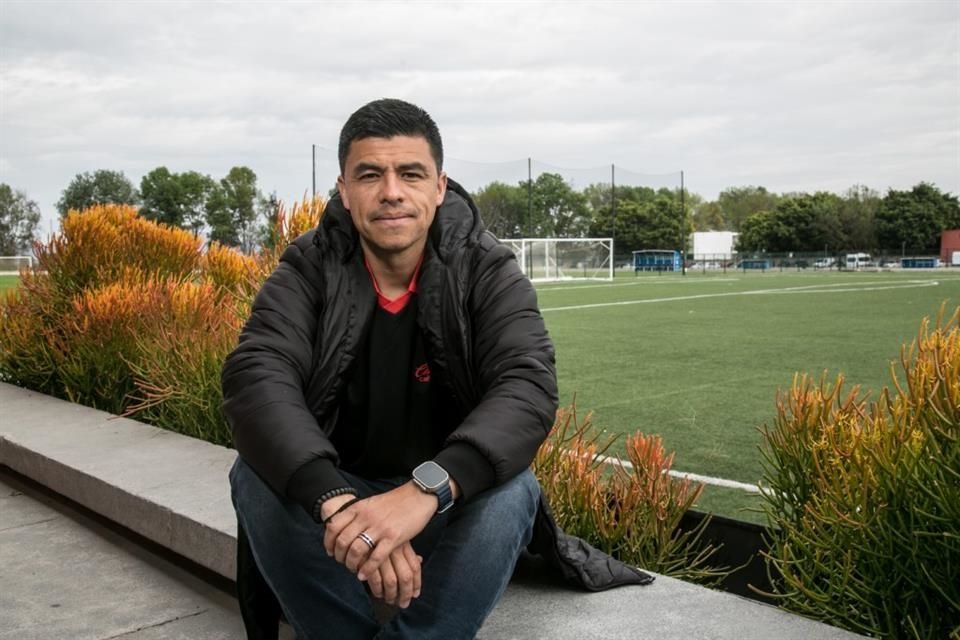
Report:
0,383,860,640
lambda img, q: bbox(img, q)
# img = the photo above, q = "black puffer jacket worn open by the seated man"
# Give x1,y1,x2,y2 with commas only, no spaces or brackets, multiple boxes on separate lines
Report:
223,176,650,590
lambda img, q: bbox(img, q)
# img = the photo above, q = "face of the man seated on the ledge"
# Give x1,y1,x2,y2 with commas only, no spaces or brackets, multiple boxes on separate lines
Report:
337,136,447,259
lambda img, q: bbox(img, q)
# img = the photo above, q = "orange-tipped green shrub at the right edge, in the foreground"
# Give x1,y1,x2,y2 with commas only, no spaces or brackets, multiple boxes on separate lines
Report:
763,307,960,638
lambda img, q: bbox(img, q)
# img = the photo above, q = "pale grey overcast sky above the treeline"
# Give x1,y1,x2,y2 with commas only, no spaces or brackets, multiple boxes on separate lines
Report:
0,0,960,238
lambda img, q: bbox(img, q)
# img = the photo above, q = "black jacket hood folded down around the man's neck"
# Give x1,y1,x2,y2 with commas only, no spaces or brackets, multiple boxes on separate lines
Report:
313,178,484,262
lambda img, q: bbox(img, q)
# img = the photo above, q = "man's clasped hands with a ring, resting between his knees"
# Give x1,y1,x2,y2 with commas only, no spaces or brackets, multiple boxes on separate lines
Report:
321,482,437,584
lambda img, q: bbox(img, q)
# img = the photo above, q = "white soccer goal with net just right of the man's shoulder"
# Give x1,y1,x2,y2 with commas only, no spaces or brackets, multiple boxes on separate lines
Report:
501,238,613,282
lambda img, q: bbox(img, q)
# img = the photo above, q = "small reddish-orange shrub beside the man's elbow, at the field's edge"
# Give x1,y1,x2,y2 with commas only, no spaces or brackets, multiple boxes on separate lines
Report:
533,405,729,584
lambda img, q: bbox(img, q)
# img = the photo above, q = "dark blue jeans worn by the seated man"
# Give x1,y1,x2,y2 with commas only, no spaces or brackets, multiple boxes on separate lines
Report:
230,458,540,640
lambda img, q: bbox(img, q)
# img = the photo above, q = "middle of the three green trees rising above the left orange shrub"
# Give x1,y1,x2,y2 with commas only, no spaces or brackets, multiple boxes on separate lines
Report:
140,167,215,236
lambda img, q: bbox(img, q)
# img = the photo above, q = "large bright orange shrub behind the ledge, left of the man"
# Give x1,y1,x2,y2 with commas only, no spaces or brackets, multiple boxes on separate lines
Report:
0,199,324,444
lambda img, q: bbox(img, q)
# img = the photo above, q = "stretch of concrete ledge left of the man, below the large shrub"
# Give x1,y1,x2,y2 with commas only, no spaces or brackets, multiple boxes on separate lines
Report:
0,384,237,579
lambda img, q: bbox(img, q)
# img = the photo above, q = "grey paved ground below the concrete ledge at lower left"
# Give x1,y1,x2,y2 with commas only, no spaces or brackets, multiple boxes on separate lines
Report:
0,471,253,640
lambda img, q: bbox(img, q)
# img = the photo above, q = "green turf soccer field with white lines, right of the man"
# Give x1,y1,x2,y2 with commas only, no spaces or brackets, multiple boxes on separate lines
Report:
537,270,960,520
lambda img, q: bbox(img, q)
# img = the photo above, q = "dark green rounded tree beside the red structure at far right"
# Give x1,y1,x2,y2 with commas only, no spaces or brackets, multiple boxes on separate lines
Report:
876,182,960,253
